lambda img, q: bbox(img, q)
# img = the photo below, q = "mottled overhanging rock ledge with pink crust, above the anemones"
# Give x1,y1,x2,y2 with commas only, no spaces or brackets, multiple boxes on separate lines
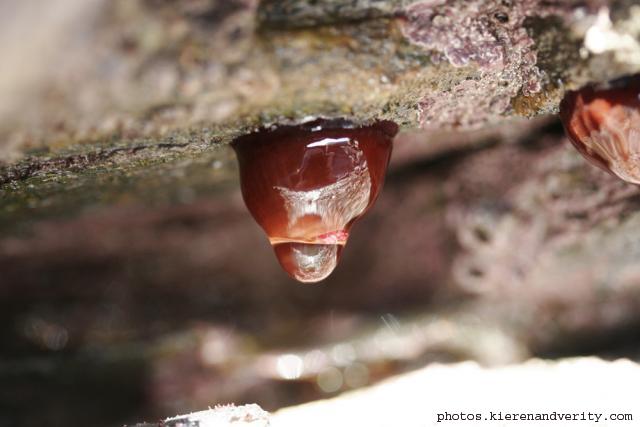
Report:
0,0,639,154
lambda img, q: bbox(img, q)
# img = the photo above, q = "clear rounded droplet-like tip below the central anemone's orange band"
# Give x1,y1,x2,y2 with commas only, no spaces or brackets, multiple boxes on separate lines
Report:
273,242,343,283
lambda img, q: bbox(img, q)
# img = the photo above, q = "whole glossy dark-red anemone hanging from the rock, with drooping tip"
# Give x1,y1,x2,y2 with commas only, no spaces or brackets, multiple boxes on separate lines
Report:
232,121,397,282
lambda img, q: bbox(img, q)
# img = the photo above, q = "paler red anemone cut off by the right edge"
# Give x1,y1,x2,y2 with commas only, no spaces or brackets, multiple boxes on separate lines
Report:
560,76,640,184
